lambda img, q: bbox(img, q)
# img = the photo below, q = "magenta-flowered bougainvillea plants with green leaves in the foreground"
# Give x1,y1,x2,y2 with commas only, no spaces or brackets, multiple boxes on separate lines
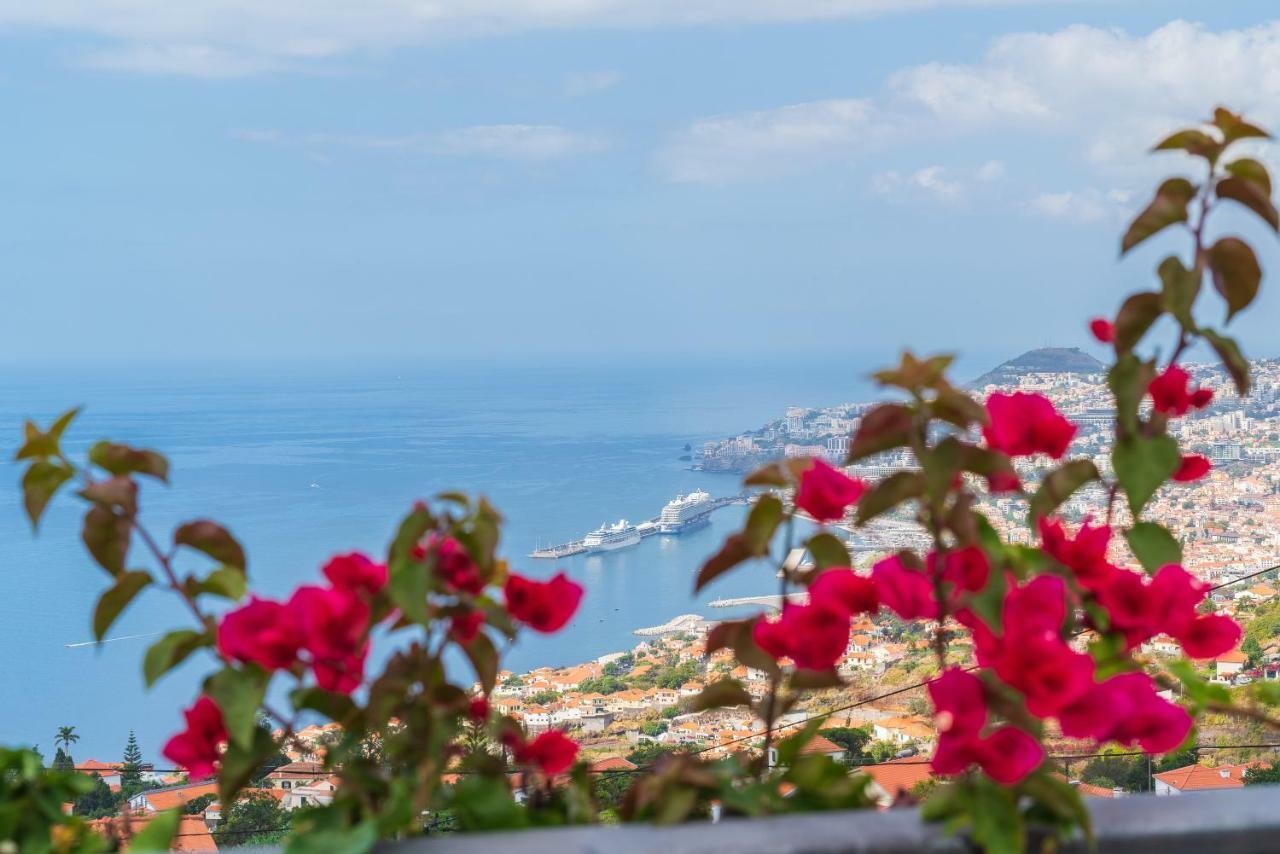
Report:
10,103,1280,853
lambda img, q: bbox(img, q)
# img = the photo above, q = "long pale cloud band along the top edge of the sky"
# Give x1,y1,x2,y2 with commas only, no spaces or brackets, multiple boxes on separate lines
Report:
0,0,1070,77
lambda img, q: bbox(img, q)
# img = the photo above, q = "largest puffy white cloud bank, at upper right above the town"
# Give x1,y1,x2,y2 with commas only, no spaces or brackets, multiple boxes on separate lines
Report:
657,20,1280,182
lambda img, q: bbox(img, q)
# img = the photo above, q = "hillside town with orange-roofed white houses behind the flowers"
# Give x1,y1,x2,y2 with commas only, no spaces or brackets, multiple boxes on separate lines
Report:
55,351,1280,850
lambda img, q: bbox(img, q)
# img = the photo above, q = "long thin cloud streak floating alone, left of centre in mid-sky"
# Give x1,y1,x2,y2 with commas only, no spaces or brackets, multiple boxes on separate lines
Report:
232,124,608,163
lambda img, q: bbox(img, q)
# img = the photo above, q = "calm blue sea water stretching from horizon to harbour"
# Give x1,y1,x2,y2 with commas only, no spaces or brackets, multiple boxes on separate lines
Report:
0,361,868,759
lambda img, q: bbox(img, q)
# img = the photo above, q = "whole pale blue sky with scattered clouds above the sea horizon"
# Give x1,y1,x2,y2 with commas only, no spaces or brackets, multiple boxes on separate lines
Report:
0,0,1280,371
